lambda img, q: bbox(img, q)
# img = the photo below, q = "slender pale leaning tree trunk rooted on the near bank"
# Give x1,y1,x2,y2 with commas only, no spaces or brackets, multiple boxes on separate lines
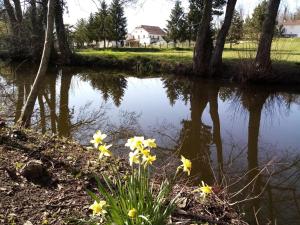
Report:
19,0,55,127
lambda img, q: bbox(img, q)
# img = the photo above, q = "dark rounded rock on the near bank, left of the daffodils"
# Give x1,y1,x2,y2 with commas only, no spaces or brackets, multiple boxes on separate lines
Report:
20,160,52,185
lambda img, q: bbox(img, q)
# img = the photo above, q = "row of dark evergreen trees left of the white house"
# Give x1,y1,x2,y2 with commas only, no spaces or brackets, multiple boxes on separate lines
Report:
74,0,127,48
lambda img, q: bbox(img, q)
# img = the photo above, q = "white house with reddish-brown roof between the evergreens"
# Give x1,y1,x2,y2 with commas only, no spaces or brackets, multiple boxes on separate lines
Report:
127,25,166,45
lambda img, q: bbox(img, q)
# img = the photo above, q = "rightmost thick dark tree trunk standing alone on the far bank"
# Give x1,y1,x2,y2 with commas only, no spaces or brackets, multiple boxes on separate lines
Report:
255,0,280,74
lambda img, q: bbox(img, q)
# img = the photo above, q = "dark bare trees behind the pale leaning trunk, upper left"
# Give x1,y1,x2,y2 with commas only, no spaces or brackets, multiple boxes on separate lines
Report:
0,0,71,63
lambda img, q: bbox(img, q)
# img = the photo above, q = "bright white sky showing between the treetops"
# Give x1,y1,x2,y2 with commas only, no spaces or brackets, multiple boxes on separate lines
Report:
65,0,300,32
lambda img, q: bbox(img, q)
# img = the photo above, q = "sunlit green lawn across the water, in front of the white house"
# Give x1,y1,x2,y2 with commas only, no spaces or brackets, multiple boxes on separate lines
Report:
78,38,300,63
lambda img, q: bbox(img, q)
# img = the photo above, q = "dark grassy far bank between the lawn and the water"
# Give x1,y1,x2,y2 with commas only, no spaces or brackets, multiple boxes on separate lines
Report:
71,54,300,84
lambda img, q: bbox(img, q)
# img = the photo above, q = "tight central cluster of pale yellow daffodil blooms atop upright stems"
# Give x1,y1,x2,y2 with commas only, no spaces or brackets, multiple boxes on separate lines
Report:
125,137,157,167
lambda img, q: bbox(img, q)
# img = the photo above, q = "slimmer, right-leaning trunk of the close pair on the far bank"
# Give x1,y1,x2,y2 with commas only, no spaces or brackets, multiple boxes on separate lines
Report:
210,0,237,75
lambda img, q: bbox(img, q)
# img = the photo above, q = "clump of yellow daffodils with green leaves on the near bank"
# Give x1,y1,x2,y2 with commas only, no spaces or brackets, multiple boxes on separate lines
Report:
88,131,192,225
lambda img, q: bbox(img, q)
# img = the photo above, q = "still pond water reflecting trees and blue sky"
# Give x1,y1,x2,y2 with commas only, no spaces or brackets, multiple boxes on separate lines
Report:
0,66,300,225
